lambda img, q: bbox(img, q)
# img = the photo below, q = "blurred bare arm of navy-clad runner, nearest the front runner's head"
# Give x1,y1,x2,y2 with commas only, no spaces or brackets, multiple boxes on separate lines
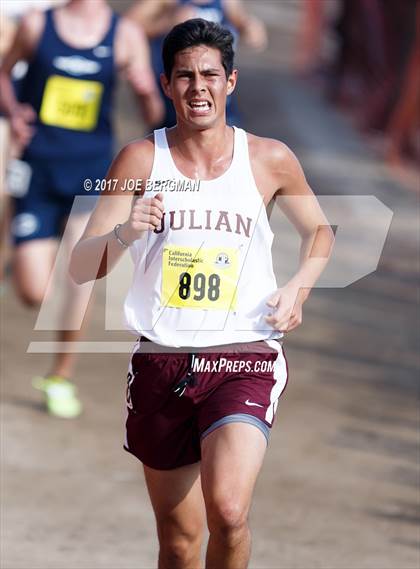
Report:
115,18,164,126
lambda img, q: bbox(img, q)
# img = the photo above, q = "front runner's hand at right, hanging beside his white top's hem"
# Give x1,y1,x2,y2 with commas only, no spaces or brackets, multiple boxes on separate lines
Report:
265,286,305,332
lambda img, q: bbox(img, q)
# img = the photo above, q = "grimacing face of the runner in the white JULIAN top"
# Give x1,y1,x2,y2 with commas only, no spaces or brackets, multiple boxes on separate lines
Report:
161,45,237,129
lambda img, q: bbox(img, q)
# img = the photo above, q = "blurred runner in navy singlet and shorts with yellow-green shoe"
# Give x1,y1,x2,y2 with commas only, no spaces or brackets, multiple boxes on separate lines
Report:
0,0,163,418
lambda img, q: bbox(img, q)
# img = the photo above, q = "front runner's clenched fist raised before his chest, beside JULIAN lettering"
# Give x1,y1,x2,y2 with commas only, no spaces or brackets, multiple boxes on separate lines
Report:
121,194,164,243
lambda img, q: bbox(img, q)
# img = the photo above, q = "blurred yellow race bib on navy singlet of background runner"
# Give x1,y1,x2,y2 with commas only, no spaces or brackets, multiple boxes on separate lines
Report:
40,75,103,131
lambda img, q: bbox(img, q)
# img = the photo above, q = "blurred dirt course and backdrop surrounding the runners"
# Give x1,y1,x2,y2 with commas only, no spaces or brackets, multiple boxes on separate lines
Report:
0,0,420,569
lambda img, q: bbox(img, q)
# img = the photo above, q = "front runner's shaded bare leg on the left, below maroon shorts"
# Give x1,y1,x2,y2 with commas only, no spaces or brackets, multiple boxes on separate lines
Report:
144,464,205,569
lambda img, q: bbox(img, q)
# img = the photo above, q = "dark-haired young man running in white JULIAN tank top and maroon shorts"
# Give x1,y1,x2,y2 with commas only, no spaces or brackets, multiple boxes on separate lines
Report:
70,19,332,569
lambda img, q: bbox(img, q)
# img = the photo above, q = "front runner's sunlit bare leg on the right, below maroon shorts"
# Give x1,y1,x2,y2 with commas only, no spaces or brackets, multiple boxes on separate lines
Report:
201,423,267,569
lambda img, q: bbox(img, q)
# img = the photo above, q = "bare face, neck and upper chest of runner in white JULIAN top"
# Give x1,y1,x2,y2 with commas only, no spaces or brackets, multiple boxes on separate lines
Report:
161,45,237,180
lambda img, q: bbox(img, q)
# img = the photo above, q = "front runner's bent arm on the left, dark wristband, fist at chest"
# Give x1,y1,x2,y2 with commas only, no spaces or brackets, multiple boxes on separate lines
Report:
70,137,163,284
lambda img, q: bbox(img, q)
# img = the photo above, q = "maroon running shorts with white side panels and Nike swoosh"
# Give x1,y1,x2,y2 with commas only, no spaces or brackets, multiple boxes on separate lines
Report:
124,337,287,470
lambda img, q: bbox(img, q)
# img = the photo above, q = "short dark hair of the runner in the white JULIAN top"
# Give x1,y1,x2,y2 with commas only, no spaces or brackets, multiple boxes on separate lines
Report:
162,18,235,79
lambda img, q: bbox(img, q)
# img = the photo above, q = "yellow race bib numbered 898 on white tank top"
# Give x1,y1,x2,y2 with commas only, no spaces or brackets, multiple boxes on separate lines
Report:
161,245,238,311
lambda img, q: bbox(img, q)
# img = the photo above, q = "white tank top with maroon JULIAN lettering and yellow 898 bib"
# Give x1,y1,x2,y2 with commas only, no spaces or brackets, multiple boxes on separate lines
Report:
124,127,282,347
